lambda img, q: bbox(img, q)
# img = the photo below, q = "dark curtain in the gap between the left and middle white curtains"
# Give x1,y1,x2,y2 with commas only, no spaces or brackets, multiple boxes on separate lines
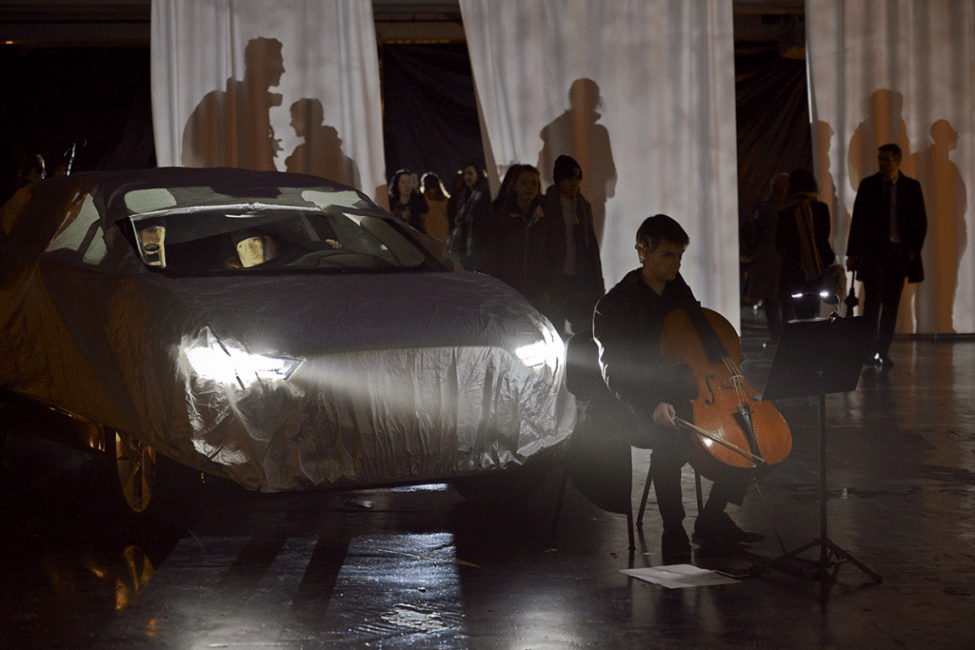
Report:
381,43,484,191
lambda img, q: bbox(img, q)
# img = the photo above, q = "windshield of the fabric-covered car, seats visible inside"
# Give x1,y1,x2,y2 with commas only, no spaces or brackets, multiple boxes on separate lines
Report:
130,204,432,276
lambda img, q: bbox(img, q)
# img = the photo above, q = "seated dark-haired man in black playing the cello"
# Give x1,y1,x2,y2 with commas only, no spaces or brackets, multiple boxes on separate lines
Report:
593,214,764,561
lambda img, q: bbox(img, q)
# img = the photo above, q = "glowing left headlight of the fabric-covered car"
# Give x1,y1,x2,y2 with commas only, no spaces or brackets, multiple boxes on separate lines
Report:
180,338,301,388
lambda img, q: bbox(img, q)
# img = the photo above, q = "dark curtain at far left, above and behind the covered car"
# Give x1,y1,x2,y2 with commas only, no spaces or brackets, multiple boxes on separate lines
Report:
0,47,156,200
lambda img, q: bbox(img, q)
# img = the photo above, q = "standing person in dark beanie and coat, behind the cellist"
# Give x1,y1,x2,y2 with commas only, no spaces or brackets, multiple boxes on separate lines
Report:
544,155,606,338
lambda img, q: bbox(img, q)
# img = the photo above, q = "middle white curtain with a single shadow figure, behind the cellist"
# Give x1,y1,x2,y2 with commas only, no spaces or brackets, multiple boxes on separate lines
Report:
460,0,740,327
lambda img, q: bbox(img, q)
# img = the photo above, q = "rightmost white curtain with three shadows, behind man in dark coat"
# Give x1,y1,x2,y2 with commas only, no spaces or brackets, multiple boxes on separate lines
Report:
806,0,975,334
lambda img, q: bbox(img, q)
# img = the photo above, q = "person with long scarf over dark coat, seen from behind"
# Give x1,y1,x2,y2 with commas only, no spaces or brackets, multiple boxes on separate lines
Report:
775,169,836,322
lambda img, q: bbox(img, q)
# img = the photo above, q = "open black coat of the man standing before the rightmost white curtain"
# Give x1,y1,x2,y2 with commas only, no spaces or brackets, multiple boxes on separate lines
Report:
846,172,928,282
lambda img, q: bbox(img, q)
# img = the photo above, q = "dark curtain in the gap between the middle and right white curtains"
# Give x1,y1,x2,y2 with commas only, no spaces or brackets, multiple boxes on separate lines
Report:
735,50,812,221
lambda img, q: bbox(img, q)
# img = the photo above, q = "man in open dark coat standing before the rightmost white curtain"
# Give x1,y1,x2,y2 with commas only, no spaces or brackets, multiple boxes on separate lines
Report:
846,144,928,371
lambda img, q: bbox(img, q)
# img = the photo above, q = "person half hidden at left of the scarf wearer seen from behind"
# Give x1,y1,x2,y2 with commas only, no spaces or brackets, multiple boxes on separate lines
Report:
747,172,789,346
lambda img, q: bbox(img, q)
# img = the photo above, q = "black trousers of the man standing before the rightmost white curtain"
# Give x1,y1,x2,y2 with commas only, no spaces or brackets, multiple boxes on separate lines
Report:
857,244,911,357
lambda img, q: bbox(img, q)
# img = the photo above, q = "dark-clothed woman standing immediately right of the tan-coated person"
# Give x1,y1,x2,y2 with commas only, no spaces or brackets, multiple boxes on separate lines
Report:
447,163,491,271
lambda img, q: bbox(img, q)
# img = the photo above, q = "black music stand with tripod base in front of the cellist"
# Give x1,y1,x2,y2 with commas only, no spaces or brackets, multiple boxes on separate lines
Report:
762,313,883,583
